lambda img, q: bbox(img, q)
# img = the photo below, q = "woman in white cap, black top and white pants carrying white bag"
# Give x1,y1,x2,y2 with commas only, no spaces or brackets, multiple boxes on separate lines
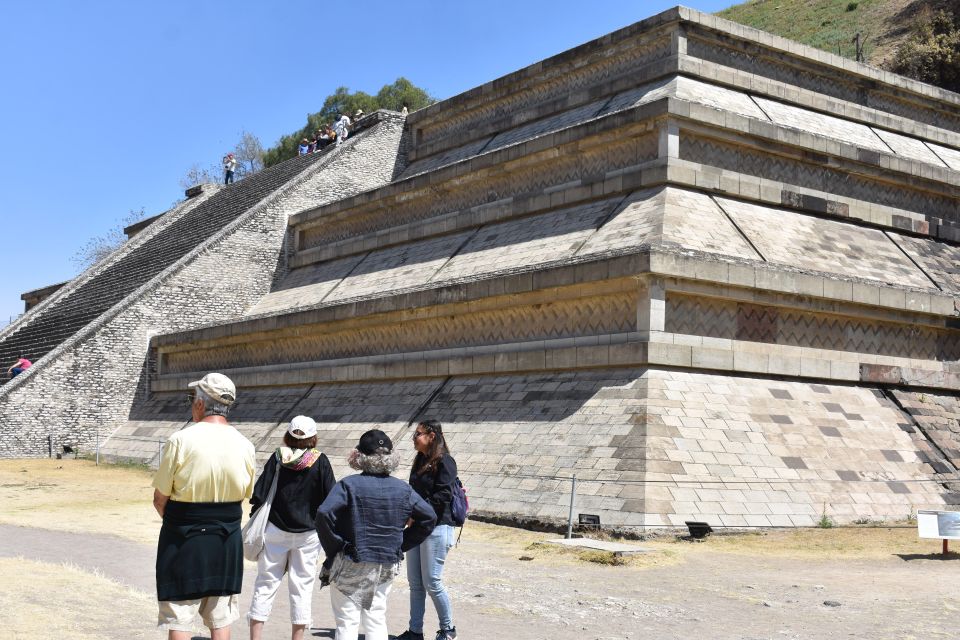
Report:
247,416,336,640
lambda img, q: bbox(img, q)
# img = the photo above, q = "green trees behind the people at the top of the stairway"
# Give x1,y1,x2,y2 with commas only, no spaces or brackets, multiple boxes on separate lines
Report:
263,78,436,167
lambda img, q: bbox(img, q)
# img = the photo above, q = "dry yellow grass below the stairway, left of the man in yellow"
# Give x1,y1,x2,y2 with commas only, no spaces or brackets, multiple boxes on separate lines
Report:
0,459,160,543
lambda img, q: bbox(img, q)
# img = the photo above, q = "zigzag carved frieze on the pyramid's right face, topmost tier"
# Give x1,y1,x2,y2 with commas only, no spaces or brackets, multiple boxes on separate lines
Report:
687,33,960,131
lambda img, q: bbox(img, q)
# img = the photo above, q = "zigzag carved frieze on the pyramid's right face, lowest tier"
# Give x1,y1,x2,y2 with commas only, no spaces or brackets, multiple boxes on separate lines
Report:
666,294,960,361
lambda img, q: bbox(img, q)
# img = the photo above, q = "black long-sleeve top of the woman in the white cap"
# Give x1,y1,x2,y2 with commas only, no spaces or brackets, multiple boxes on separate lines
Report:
250,453,337,533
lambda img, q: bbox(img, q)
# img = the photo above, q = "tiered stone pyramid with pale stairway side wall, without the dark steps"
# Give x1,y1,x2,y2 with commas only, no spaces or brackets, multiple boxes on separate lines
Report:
0,7,960,529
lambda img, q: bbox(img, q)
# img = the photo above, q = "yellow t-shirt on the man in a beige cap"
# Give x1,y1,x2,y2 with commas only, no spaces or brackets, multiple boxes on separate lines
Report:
153,422,256,502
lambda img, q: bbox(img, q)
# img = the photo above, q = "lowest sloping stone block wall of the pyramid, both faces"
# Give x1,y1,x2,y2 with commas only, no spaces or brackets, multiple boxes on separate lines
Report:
105,368,960,528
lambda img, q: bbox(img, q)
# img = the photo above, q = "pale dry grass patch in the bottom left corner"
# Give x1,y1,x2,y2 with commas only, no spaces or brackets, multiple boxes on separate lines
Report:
0,558,165,640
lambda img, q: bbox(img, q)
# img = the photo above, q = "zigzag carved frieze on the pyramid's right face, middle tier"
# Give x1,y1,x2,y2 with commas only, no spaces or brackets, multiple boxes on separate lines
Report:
680,134,960,224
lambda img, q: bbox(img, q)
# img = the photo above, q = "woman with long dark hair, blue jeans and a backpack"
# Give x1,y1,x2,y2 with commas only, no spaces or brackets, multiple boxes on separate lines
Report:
397,420,457,640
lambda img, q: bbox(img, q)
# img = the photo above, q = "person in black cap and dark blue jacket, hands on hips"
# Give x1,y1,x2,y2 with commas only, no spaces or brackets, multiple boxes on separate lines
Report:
316,429,437,640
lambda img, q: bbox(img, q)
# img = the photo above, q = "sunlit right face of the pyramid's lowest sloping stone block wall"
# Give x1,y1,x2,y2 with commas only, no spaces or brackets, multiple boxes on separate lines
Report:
645,371,957,526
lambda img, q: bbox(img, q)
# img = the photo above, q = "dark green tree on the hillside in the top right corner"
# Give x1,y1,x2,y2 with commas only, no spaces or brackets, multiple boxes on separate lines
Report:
890,11,960,92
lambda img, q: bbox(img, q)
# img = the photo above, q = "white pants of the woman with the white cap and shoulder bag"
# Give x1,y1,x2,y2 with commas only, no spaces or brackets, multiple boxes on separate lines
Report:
247,524,320,626
